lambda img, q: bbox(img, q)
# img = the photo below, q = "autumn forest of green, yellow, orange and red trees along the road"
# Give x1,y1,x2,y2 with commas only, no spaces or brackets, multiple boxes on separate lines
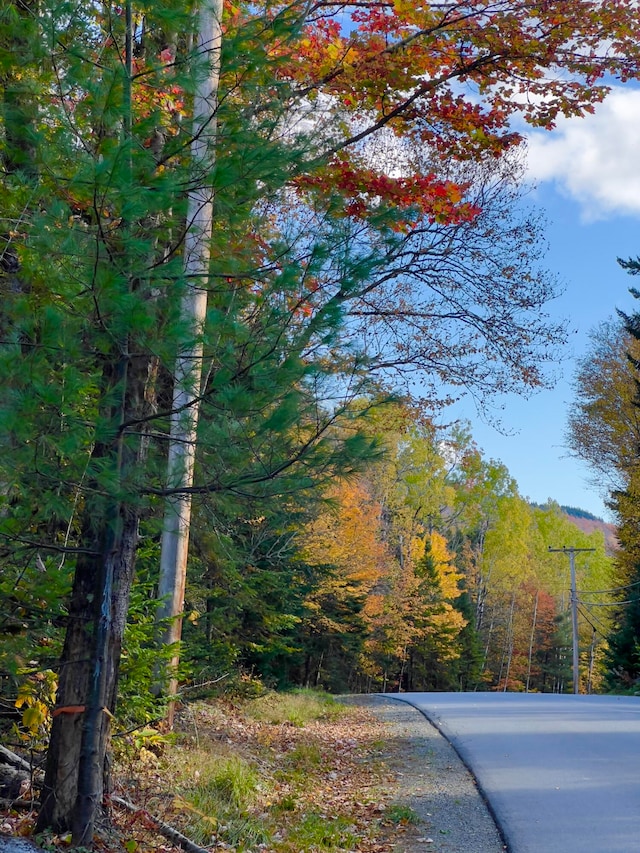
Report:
0,0,640,846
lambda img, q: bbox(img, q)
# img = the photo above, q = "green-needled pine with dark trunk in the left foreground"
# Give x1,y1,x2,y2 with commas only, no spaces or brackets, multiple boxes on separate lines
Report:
1,0,380,844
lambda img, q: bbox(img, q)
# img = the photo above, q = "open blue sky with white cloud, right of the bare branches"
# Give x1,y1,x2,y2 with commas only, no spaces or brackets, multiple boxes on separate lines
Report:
453,87,640,521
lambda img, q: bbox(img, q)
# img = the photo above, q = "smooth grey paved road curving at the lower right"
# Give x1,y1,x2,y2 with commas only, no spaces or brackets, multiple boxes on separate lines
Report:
386,693,640,853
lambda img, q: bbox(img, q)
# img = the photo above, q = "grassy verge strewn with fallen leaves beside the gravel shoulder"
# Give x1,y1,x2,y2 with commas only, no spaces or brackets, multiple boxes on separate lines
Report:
105,690,416,853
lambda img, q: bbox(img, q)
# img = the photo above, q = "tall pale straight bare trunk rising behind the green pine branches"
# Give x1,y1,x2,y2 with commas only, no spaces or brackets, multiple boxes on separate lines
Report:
158,0,223,724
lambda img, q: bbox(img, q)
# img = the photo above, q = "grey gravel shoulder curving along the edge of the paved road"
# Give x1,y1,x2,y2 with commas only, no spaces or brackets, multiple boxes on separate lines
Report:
342,695,507,853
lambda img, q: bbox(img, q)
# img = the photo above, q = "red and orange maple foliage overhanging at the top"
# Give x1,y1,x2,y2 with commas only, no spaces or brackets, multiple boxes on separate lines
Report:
249,0,640,221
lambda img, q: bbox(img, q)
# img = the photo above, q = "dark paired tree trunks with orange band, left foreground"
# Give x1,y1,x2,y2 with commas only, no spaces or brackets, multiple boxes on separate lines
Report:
37,355,154,847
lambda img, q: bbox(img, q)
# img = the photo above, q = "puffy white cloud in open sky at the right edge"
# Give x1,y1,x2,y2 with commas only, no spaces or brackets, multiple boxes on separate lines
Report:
527,87,640,220
